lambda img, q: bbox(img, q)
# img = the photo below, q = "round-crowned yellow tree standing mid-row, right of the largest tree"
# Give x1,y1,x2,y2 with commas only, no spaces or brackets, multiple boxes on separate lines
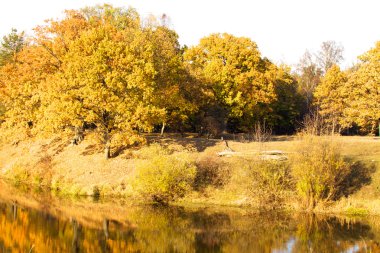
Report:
184,34,275,133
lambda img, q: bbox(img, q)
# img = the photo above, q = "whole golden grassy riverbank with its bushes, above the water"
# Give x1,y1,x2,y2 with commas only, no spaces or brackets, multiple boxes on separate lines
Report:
0,133,380,214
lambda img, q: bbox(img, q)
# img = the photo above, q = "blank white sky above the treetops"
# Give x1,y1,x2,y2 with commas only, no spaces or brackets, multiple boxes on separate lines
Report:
0,0,380,68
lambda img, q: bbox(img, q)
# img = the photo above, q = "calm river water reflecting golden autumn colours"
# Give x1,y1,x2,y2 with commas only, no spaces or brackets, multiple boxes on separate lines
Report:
0,189,380,252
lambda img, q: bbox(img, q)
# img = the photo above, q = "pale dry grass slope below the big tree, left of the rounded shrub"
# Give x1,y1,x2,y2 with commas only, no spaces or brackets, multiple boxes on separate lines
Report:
0,135,135,195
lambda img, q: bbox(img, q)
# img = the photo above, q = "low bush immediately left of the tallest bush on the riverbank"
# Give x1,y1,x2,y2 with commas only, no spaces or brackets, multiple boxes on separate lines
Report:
249,159,292,209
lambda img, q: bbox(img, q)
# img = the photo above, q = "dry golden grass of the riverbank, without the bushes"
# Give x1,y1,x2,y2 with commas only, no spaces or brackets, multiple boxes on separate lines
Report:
0,137,380,215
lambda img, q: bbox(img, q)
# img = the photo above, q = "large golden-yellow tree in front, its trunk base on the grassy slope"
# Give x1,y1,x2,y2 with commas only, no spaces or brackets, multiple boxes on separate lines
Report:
44,7,164,158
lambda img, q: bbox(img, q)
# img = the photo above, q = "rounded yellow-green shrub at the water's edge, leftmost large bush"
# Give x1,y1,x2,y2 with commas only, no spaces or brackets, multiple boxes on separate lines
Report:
134,154,196,203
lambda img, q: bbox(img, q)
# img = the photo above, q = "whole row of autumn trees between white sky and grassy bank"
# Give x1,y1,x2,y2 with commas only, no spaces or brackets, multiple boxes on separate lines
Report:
0,5,380,156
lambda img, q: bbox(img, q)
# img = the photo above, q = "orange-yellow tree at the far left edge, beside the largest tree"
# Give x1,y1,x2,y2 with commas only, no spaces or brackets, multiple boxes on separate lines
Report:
0,45,57,136
